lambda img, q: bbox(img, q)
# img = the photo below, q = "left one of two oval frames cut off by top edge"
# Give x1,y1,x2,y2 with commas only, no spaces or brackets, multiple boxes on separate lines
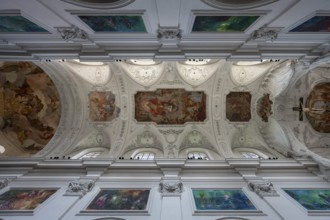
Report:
62,0,135,9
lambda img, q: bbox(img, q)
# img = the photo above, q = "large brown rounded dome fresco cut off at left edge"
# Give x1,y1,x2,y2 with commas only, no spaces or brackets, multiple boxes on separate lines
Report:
0,62,61,156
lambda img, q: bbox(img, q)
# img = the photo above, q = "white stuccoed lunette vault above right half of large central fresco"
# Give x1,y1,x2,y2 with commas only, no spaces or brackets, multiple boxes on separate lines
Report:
176,59,225,86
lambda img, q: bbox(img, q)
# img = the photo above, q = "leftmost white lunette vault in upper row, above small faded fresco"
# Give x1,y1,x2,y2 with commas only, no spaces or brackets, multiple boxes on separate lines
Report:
65,61,111,86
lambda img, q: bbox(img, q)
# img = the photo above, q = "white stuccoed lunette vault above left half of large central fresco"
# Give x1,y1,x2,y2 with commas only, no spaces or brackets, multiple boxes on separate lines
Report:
120,60,165,87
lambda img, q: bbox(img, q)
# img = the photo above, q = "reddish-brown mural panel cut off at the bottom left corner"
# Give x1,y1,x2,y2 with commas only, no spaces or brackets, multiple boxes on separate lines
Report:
0,189,56,211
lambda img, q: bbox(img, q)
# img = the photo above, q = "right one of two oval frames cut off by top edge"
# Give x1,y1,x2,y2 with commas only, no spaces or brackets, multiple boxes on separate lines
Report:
201,0,278,10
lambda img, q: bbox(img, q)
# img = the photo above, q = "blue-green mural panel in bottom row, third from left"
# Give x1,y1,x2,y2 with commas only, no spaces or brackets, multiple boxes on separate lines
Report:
193,189,256,211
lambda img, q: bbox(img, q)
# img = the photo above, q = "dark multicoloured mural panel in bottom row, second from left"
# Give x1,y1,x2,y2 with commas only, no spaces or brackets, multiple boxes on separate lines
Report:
86,189,150,211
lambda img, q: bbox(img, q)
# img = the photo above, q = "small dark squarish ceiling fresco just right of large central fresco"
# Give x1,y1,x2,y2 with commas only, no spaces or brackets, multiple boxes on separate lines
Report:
226,92,251,121
